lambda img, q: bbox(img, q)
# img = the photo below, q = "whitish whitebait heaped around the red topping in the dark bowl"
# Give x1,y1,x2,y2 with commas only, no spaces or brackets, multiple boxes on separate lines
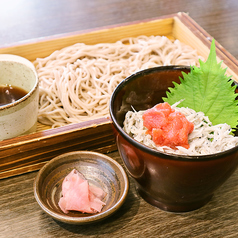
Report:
123,103,238,155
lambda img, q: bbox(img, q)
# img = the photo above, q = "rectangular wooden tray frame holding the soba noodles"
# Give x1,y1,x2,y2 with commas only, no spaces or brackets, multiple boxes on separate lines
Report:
0,13,238,179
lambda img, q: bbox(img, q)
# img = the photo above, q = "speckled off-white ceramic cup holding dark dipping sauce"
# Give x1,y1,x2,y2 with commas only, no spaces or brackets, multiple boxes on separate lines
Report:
0,54,39,140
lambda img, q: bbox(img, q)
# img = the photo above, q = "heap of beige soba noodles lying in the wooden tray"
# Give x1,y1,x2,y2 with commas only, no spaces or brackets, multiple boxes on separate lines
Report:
34,36,203,127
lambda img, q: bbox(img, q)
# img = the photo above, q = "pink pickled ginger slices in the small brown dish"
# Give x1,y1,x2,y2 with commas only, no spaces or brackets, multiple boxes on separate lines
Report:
59,169,106,213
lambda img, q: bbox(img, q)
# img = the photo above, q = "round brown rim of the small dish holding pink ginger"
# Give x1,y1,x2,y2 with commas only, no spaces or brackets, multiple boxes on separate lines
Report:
33,151,130,225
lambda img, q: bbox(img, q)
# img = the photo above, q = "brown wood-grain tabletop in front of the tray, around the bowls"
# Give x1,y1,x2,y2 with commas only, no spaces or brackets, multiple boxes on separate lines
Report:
0,152,238,238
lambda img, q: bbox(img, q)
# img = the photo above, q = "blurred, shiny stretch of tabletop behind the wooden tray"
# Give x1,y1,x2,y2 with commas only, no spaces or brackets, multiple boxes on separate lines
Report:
0,0,238,58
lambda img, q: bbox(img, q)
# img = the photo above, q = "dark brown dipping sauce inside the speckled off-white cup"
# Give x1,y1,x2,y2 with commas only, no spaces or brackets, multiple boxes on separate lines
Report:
0,85,27,106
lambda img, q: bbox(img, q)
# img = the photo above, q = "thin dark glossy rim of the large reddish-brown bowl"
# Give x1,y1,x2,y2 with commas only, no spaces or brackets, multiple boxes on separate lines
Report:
109,65,238,162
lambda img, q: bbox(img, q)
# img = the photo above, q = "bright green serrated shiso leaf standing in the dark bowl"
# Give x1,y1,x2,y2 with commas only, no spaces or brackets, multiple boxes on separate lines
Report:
163,39,238,128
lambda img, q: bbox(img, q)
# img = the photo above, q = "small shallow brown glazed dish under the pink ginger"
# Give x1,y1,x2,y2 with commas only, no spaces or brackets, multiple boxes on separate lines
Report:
34,151,129,224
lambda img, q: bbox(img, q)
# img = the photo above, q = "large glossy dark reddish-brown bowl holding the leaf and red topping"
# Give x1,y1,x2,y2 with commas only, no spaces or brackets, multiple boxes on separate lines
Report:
110,66,238,212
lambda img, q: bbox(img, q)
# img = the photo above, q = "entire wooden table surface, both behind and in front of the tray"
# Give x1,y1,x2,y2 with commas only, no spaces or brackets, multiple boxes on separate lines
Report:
0,0,238,238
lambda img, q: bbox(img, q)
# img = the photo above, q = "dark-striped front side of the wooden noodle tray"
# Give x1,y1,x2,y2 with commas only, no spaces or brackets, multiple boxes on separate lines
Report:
0,118,116,179
